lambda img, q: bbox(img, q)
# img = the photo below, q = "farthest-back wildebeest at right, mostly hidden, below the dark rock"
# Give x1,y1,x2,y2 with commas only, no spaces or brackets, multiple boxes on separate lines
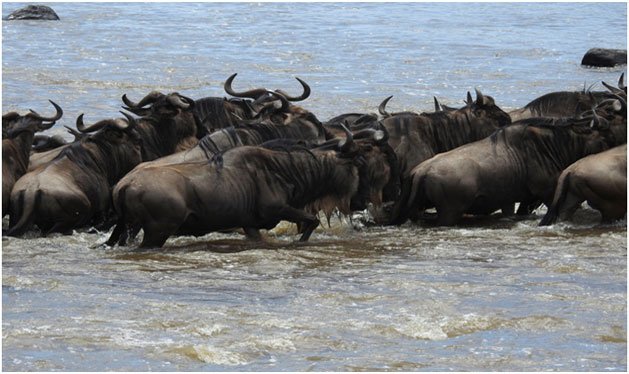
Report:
509,73,627,122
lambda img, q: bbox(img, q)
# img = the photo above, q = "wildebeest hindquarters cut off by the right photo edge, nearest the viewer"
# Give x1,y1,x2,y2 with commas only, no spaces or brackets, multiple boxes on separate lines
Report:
540,144,627,226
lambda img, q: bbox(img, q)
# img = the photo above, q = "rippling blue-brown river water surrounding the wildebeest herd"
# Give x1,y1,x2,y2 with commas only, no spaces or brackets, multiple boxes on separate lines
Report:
2,3,627,371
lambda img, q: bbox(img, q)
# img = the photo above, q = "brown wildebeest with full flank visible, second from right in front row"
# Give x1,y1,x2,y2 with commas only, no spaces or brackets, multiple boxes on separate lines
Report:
393,99,627,226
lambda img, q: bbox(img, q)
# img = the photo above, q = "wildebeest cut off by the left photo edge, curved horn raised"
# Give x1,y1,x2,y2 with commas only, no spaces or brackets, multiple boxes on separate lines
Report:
2,101,63,217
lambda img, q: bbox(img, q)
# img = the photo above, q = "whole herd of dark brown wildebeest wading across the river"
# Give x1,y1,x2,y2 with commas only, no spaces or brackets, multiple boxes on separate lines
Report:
2,74,627,247
